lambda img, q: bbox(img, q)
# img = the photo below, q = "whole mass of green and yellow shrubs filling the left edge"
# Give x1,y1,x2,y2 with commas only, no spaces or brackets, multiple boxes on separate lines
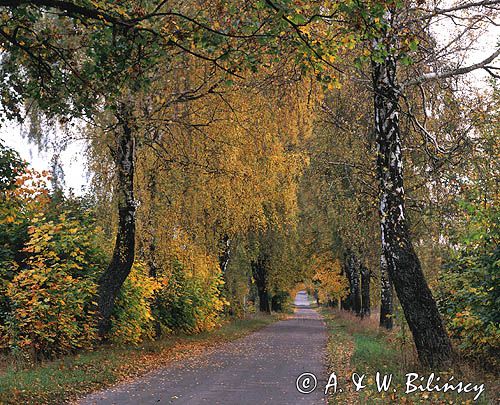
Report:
0,166,107,360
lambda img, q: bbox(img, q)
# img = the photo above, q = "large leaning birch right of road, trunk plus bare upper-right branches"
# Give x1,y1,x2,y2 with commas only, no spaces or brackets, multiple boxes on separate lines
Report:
360,2,500,366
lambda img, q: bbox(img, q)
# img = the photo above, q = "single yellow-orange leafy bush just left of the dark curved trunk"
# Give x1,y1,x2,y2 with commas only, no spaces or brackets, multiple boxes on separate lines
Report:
3,214,100,358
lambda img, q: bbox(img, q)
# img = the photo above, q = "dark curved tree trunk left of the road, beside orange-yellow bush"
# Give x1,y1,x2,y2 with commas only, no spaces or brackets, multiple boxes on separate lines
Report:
97,109,136,337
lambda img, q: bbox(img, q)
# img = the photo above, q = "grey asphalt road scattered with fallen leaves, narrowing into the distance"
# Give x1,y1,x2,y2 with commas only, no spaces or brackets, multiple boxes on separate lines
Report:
79,292,327,405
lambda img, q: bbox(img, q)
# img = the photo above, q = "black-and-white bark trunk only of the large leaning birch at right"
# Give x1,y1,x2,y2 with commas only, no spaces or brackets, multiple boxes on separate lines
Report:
372,33,452,366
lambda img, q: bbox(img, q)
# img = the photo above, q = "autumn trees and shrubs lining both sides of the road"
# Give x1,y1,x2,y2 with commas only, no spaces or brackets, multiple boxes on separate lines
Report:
0,0,500,403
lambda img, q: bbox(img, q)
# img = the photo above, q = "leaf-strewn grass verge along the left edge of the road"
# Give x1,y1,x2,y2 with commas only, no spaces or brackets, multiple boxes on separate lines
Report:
0,315,279,405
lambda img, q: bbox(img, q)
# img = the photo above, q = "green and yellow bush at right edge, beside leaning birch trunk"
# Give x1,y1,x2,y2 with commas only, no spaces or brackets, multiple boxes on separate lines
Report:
438,197,500,368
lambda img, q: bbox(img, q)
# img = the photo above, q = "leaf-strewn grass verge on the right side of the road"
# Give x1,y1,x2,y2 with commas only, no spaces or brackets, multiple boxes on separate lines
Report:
321,308,498,404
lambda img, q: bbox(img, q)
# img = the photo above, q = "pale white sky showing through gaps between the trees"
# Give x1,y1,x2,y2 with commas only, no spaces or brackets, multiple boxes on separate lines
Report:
0,9,500,194
